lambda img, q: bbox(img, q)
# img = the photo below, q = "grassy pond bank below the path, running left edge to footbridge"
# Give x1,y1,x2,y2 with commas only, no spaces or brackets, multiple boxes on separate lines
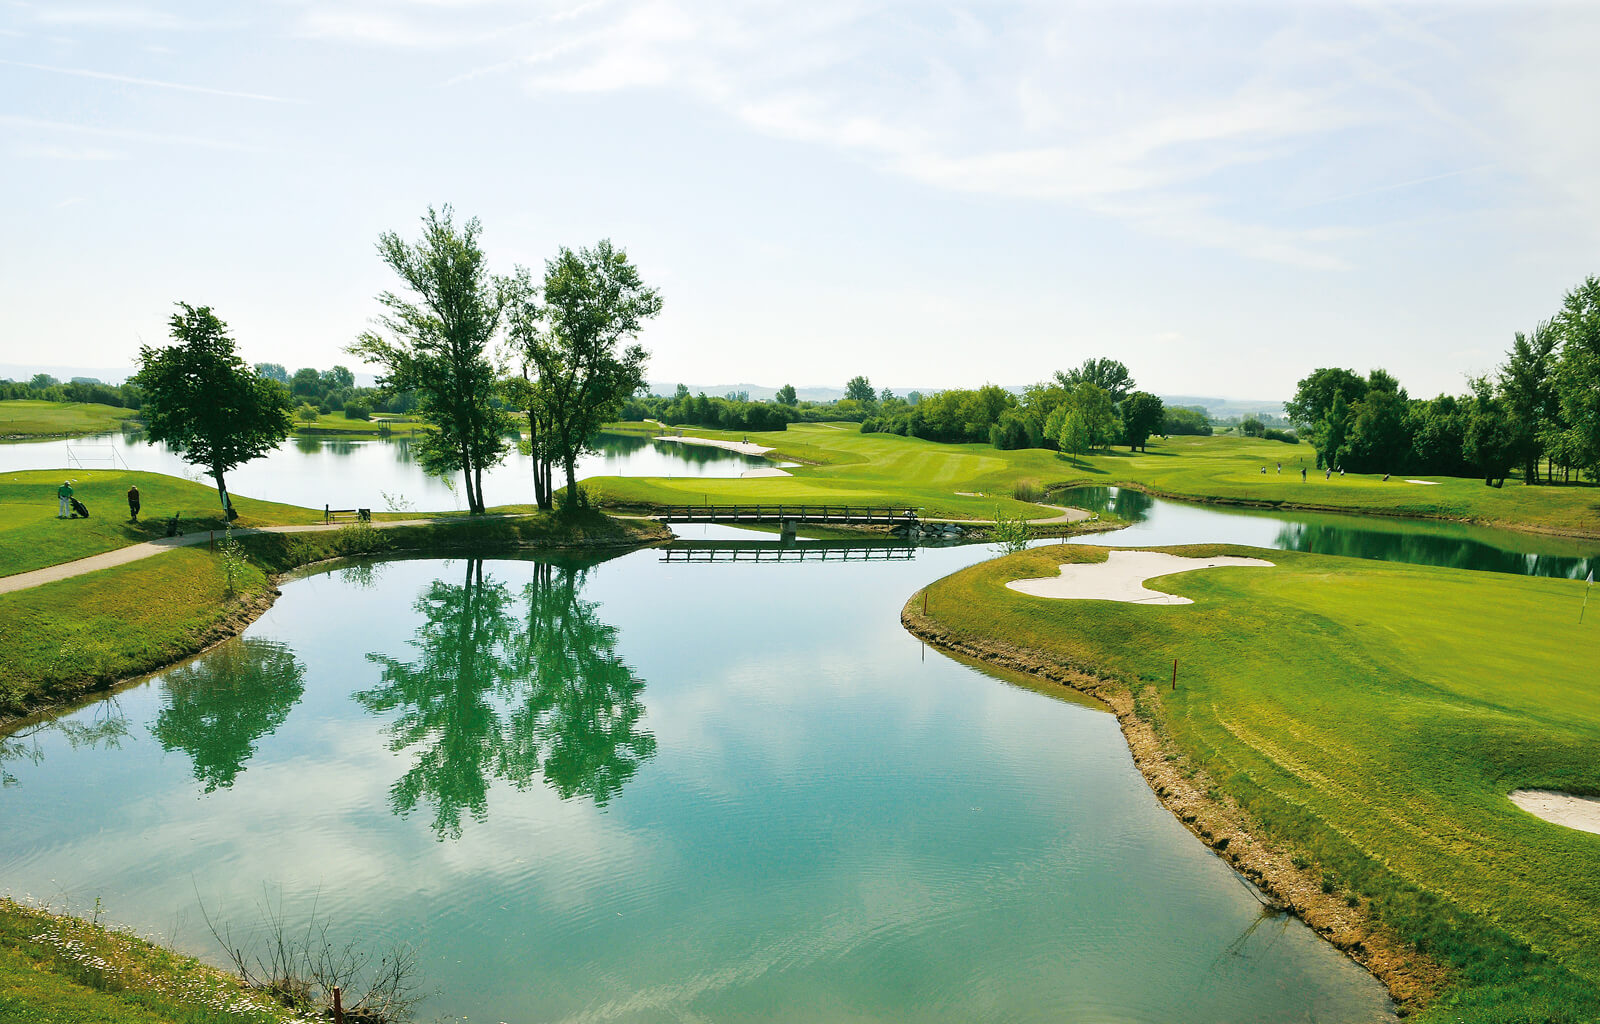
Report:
0,514,667,725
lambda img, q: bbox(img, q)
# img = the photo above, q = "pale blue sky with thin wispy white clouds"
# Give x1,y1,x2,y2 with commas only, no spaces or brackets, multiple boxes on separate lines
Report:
0,0,1600,398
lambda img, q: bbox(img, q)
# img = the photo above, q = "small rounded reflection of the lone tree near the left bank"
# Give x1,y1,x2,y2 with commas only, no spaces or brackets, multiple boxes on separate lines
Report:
150,638,306,792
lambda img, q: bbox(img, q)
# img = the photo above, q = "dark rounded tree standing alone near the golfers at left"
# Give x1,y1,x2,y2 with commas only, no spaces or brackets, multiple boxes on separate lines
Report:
133,302,293,518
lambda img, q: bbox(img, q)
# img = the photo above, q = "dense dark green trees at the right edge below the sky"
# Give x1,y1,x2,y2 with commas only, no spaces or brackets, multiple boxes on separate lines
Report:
1285,277,1600,486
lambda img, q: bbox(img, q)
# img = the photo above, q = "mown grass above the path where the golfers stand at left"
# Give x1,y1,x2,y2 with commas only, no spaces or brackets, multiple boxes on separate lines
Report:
0,469,322,576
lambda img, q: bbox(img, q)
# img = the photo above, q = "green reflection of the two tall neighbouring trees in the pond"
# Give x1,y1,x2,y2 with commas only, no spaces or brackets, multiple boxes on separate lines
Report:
355,560,656,837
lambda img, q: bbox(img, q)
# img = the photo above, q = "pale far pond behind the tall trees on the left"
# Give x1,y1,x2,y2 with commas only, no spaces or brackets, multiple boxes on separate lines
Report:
0,434,774,512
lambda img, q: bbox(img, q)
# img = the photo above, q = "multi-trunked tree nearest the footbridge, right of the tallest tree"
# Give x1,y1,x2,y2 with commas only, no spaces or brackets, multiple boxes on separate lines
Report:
502,240,661,507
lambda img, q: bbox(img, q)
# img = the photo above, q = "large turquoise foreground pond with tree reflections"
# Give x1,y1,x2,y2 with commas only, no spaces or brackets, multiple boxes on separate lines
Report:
0,528,1394,1024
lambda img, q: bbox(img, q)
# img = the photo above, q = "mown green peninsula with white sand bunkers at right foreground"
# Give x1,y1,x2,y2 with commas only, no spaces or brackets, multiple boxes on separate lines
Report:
904,546,1600,1022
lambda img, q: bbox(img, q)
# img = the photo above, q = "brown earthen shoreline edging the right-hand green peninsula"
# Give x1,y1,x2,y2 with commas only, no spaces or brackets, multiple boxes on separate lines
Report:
901,601,1448,1018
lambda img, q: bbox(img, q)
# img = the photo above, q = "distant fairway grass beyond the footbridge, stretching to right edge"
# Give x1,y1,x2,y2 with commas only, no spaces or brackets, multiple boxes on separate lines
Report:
594,424,1600,536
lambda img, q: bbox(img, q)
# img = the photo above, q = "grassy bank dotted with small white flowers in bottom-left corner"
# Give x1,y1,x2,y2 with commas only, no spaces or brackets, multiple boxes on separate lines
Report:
0,898,298,1024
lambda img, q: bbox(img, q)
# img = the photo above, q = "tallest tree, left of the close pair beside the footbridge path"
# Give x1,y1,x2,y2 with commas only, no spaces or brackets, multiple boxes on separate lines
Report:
352,206,512,514
